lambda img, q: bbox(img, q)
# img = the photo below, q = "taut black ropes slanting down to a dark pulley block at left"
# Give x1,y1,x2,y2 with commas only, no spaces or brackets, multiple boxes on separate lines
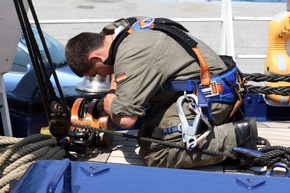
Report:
14,0,70,138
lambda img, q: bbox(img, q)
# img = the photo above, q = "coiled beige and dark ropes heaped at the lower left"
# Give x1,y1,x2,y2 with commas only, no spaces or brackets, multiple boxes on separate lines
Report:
0,134,66,192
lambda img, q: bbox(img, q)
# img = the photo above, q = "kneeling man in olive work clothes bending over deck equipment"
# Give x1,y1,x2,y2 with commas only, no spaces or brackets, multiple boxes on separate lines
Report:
66,18,257,168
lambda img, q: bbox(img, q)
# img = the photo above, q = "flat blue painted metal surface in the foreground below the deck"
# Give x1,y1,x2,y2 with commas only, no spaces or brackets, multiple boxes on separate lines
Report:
10,160,290,193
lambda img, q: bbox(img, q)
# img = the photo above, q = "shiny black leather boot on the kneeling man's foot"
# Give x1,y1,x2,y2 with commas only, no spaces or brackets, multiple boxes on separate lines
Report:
233,118,258,150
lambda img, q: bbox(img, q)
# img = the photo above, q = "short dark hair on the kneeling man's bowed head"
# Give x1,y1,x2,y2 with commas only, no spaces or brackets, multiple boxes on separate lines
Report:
65,32,105,77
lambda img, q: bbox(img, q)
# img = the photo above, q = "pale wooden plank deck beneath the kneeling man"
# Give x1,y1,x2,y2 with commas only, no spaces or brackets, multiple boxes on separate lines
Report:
73,121,290,173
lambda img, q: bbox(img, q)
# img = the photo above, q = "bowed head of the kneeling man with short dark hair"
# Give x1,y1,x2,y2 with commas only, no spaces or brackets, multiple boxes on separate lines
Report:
65,32,112,77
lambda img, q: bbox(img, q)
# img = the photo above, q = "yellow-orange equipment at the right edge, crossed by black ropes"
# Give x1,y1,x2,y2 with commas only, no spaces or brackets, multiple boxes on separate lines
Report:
264,11,290,106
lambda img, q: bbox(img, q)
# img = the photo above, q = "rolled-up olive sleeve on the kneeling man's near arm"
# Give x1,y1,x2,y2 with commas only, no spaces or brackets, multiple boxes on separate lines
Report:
111,62,162,116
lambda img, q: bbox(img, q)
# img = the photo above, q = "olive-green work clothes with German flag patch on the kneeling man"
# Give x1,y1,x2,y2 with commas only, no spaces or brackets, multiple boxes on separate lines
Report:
102,19,237,168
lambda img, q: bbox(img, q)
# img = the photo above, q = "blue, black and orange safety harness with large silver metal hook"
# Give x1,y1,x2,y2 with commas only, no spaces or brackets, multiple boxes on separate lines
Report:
110,17,243,150
